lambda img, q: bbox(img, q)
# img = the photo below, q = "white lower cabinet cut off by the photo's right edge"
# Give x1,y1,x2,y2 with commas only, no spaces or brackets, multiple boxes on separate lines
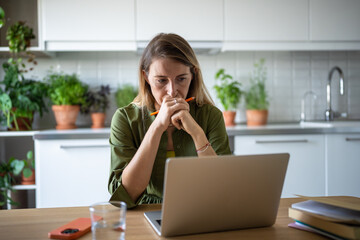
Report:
326,134,360,197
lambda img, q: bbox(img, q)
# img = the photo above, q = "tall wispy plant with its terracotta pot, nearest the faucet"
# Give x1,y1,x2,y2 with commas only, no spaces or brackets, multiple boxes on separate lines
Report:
245,59,269,126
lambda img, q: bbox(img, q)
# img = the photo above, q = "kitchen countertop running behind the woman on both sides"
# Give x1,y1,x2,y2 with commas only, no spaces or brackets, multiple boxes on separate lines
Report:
0,121,360,140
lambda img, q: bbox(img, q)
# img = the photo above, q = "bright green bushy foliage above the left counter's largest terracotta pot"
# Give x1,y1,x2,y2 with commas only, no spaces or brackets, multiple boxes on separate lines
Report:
45,72,88,106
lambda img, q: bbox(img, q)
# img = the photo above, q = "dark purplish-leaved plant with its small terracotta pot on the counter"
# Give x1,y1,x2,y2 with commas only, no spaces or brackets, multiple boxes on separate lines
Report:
85,85,110,128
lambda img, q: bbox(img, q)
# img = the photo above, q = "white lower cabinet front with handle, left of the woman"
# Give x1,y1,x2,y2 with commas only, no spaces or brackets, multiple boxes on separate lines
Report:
35,138,110,208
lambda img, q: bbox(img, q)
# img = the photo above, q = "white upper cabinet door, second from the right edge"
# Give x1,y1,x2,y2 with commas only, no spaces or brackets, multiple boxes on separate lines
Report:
224,0,309,41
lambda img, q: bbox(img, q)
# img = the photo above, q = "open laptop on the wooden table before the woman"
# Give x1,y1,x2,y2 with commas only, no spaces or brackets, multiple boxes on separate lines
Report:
144,153,290,237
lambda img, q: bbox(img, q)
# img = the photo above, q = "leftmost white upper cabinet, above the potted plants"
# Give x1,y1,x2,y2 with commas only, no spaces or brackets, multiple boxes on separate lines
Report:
42,0,135,51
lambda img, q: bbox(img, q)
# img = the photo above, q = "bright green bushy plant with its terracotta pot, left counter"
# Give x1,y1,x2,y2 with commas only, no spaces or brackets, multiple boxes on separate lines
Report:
45,72,88,129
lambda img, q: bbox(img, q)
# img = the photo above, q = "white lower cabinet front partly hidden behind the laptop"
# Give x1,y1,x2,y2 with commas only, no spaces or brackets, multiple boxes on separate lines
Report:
234,134,325,197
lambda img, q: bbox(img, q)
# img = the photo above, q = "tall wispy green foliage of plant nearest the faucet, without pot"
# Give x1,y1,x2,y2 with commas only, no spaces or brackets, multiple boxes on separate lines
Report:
245,58,269,110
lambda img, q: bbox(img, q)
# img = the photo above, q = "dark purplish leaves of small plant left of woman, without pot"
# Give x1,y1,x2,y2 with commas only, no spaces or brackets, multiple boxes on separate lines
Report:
84,85,110,113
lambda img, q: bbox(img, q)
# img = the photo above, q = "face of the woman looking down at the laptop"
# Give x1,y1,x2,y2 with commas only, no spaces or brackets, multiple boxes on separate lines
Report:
144,58,192,109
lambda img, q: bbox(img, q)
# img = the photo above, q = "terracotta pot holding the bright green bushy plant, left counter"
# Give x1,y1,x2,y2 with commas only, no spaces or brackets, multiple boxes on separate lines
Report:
52,105,80,129
